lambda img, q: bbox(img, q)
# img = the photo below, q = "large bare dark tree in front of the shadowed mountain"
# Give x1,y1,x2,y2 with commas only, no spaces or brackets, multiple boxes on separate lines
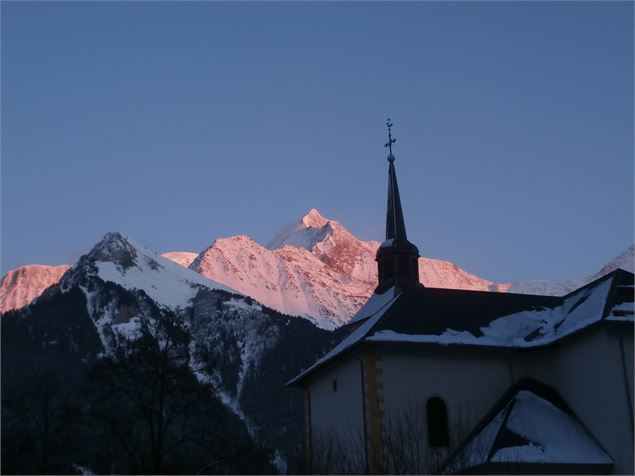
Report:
86,313,272,474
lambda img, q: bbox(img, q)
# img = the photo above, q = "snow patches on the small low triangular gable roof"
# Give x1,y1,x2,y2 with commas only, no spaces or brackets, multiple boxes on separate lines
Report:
448,390,613,473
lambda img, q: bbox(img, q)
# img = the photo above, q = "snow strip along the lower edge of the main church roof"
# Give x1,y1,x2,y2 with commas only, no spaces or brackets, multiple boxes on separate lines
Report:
365,277,620,347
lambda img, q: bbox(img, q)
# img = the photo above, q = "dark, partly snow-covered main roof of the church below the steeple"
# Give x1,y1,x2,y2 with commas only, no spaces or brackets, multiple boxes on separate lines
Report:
289,269,633,385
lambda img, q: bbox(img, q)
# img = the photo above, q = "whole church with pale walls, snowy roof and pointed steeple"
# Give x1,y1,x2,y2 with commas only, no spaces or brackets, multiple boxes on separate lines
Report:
288,131,634,474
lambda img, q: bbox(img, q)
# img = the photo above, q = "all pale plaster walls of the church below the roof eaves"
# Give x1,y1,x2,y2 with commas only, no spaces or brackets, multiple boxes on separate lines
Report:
307,327,634,474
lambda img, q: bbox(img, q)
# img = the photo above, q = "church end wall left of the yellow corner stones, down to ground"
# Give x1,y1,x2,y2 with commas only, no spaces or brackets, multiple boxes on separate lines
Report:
307,356,364,472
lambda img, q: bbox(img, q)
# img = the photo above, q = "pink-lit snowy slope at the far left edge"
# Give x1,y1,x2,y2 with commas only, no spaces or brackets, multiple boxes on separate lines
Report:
0,264,70,312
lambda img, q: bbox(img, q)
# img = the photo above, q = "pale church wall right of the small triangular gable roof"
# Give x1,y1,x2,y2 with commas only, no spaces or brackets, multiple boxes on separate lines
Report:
512,327,633,474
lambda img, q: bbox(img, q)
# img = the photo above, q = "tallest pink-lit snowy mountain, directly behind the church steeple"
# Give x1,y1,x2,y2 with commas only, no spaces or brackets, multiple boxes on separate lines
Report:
190,209,504,328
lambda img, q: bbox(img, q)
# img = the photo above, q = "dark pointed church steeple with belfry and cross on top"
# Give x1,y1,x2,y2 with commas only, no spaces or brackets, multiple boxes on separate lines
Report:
375,119,420,293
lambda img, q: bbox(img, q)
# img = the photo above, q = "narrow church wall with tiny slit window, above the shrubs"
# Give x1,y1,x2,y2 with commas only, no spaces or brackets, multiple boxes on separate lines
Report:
308,356,364,456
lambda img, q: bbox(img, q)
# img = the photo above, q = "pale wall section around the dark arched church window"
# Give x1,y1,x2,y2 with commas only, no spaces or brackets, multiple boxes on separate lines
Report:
378,345,511,445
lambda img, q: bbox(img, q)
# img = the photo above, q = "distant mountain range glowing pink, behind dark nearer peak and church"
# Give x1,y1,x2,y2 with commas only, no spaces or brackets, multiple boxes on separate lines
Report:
0,209,634,329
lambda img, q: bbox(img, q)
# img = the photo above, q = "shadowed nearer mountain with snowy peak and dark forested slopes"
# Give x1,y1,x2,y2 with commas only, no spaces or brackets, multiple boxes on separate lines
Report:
2,233,337,471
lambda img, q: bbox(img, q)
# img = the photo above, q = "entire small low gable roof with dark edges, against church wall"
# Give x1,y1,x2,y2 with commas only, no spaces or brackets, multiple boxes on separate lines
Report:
444,379,613,474
